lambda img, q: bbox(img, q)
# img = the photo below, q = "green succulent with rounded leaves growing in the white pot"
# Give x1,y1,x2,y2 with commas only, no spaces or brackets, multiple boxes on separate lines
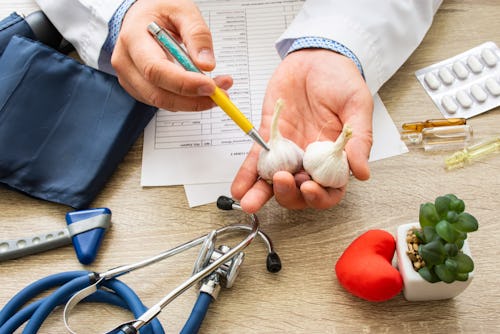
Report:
414,194,478,283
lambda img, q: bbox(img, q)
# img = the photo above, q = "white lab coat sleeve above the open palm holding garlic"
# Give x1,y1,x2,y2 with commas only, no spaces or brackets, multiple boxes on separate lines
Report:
276,0,442,94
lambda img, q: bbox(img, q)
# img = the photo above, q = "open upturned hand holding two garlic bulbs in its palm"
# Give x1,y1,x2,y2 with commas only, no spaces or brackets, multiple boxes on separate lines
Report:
231,49,373,212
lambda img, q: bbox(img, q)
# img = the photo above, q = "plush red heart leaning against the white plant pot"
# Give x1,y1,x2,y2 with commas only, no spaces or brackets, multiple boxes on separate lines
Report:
335,230,403,302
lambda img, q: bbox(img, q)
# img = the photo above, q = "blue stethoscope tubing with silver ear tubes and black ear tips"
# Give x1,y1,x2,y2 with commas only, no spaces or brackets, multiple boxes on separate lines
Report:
0,200,281,334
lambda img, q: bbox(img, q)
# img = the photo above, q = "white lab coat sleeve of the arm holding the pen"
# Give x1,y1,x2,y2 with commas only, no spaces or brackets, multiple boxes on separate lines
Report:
36,0,122,68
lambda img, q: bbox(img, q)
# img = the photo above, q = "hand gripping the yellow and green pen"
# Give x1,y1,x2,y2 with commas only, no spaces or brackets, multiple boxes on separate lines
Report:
111,0,233,111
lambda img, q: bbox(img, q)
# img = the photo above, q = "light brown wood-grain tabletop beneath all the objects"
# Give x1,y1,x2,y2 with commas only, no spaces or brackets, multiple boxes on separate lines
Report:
0,0,500,333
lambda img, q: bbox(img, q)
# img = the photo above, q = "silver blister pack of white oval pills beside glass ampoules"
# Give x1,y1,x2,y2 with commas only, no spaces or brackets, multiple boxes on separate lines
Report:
415,42,500,118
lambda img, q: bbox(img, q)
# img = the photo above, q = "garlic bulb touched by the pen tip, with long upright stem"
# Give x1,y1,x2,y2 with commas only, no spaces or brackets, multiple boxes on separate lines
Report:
257,99,304,182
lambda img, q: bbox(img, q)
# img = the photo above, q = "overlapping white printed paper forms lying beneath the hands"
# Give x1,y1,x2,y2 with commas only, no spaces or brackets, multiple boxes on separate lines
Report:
141,0,407,206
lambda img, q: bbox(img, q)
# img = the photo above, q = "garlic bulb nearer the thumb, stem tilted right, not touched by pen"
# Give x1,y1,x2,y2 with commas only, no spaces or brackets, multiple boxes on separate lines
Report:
303,125,352,188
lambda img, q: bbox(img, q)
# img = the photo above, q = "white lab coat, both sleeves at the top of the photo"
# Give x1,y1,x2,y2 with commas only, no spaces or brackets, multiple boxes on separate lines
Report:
36,0,442,94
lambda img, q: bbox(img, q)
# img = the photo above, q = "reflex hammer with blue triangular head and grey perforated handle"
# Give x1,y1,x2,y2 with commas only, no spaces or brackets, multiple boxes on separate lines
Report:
0,208,111,264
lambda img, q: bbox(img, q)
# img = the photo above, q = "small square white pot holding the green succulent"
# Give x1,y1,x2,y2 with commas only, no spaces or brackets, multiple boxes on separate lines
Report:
396,223,474,301
